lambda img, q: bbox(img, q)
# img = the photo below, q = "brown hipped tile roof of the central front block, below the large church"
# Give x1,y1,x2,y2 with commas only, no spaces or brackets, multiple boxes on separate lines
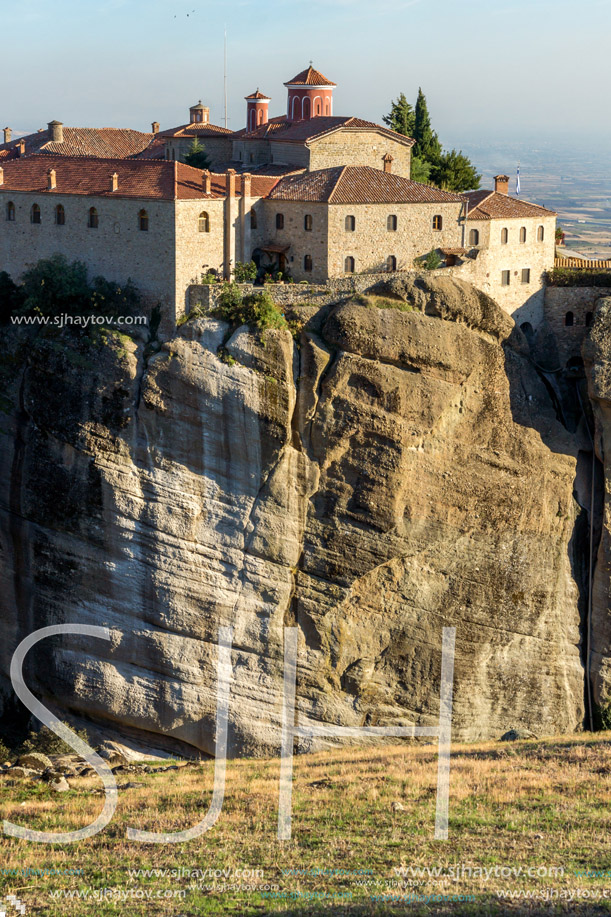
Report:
269,166,464,204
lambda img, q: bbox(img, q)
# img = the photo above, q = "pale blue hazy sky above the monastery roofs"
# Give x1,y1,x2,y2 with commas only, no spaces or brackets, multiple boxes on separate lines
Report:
0,0,611,155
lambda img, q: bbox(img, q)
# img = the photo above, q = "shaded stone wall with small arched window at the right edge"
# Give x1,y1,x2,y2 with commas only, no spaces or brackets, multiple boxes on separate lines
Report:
545,283,611,366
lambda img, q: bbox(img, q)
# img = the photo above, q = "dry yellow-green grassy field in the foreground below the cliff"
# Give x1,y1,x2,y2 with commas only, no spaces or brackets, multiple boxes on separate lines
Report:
0,733,611,917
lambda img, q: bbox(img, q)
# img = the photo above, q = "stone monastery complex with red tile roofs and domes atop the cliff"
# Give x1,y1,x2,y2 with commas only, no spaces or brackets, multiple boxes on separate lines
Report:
0,66,556,326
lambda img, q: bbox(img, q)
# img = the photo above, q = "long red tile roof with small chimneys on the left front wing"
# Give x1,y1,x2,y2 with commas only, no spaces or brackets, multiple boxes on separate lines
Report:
0,155,278,201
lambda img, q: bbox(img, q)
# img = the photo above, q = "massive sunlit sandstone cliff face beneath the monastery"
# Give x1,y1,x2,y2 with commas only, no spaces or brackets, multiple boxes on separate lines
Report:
0,278,583,754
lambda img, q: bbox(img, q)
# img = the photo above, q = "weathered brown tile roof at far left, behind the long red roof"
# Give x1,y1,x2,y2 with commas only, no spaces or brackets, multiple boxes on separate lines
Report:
0,127,155,159
